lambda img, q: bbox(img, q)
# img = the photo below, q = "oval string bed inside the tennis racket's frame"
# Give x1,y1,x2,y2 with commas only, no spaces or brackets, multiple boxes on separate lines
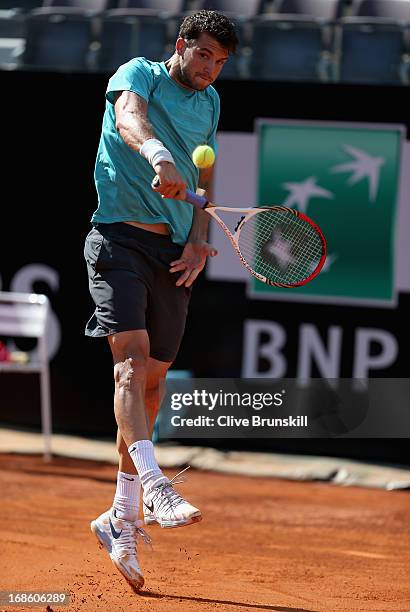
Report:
239,209,323,285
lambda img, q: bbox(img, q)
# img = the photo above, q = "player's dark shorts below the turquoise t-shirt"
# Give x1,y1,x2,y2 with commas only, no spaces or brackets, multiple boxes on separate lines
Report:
84,223,191,361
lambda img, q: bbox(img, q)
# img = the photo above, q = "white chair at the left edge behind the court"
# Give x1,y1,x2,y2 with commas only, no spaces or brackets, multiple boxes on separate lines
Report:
0,291,51,461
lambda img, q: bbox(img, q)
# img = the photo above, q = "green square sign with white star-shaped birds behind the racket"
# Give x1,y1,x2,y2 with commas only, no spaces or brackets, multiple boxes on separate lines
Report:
250,120,404,306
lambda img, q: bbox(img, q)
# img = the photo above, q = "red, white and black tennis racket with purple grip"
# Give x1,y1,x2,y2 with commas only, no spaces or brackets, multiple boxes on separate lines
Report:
153,179,326,288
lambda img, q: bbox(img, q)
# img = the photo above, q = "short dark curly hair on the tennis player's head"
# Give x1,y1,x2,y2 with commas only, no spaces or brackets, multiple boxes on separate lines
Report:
179,11,238,53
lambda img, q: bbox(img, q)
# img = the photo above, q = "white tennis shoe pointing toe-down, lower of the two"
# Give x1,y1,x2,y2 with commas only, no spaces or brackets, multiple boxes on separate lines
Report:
91,508,151,592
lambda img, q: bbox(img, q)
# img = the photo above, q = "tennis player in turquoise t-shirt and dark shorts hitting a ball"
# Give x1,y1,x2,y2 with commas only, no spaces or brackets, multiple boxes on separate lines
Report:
84,11,237,591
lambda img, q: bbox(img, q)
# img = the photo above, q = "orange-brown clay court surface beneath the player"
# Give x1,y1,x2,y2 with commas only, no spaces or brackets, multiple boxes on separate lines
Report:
0,454,410,612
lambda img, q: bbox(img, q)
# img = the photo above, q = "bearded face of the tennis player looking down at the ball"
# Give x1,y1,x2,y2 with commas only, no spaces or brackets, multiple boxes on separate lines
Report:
175,32,229,91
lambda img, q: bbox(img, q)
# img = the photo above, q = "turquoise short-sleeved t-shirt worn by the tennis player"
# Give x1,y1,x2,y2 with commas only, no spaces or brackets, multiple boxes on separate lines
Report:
91,57,220,245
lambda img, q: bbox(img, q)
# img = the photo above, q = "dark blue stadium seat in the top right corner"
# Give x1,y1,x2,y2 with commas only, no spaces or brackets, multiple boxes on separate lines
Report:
336,0,410,85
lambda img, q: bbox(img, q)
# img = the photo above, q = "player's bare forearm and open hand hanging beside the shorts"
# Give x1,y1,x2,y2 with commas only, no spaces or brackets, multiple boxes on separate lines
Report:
170,167,218,287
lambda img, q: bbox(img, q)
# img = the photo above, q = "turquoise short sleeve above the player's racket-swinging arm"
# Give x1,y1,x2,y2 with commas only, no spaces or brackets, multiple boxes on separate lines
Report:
105,57,154,104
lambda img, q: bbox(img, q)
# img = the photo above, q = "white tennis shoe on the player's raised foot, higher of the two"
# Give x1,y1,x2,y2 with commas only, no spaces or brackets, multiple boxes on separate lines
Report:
142,468,202,528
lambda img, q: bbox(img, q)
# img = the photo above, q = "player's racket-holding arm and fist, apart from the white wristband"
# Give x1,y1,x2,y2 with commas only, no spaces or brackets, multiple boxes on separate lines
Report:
114,91,186,200
